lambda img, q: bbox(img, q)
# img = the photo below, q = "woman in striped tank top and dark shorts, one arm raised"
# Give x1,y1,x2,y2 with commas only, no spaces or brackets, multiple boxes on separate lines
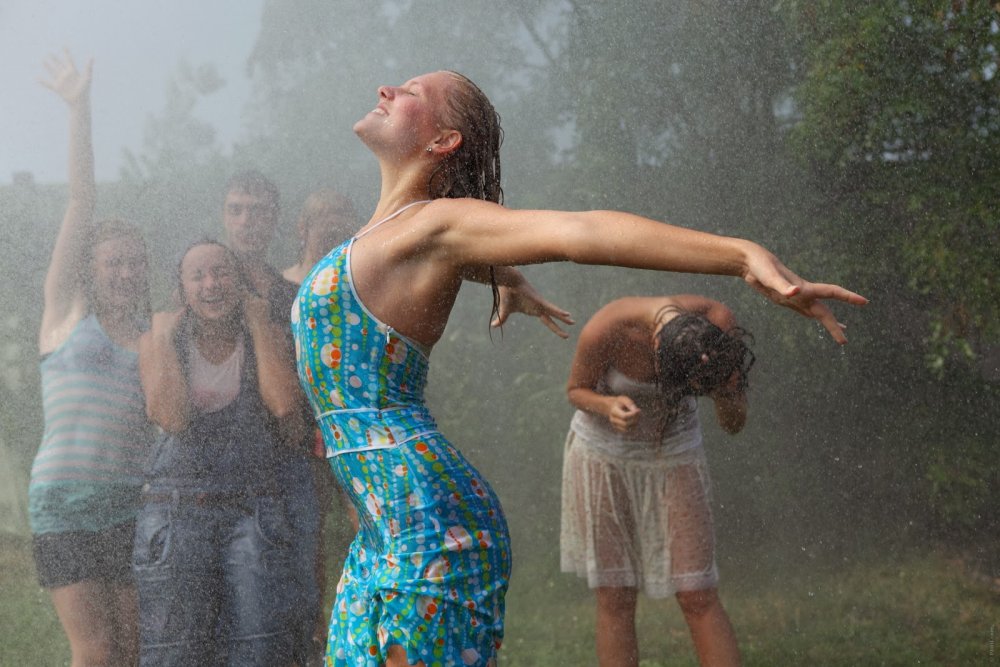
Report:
28,53,152,666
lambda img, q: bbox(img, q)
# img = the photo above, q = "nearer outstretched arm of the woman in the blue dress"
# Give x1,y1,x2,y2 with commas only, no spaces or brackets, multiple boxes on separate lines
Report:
430,199,867,343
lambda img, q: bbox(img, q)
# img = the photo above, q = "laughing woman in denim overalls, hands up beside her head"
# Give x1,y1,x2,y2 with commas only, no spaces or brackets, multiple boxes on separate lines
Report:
134,242,305,666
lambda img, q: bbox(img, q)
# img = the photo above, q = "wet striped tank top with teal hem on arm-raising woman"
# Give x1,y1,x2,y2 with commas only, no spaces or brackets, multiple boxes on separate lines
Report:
28,314,152,534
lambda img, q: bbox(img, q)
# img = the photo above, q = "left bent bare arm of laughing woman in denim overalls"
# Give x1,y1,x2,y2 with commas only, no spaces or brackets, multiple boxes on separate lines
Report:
139,310,191,433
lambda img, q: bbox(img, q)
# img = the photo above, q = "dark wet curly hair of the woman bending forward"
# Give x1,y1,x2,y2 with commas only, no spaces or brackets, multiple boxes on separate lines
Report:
656,311,756,401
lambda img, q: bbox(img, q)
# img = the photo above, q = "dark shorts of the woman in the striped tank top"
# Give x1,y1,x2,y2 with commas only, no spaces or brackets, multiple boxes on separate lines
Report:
31,521,135,588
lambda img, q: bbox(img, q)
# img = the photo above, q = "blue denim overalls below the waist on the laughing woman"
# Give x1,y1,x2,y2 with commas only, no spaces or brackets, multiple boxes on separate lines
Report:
133,494,297,667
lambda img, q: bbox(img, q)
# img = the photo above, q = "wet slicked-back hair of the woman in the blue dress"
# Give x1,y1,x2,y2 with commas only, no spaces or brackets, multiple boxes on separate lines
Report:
429,72,503,203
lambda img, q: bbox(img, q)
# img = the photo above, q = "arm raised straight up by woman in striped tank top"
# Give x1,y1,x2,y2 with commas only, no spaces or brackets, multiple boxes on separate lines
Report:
38,52,96,354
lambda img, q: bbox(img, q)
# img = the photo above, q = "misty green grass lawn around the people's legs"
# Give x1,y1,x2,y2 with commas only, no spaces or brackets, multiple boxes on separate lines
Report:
0,538,1000,667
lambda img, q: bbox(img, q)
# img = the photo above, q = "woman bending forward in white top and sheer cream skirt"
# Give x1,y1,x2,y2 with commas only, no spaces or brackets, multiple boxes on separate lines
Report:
560,295,754,667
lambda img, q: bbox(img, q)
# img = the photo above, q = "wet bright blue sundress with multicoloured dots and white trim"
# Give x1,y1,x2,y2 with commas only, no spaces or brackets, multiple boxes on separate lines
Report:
292,204,510,667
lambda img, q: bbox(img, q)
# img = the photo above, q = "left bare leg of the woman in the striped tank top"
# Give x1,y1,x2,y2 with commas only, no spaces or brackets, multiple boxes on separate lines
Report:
50,580,122,667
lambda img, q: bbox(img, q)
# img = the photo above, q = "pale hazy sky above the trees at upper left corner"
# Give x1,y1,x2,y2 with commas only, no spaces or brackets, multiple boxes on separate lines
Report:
0,0,263,184
